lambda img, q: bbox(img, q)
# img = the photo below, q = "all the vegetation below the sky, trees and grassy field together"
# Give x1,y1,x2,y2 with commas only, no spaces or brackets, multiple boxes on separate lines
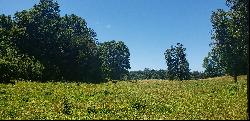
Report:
0,0,249,120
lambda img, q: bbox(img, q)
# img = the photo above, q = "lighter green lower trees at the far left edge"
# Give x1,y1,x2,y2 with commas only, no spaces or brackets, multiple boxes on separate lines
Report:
0,15,44,82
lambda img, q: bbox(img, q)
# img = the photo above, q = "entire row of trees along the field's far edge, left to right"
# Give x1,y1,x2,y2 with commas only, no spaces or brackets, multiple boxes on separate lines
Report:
0,0,249,82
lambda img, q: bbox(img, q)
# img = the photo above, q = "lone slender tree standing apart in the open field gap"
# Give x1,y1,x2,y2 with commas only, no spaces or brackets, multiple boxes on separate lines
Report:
164,43,190,80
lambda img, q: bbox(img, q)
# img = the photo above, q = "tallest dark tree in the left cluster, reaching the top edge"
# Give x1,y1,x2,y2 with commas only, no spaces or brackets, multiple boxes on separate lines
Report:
14,0,62,79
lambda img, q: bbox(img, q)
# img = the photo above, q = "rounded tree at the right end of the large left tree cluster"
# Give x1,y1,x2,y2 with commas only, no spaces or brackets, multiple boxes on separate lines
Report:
98,40,130,80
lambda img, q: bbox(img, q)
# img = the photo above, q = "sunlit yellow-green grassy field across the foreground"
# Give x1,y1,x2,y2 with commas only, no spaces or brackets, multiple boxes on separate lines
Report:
0,76,248,120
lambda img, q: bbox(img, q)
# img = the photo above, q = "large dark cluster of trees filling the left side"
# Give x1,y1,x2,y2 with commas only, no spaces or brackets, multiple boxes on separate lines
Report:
0,0,130,82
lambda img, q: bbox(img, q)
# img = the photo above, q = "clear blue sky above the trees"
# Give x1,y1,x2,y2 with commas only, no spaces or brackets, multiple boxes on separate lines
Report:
0,0,228,71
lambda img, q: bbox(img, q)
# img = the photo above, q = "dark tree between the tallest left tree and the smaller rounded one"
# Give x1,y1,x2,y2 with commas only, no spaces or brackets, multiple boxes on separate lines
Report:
57,14,102,81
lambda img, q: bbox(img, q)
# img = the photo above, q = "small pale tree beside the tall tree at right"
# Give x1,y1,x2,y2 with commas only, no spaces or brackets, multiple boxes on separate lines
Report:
202,49,224,77
